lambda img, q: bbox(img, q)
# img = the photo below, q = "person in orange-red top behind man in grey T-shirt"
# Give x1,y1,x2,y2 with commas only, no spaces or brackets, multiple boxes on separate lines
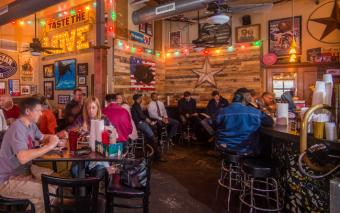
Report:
33,94,57,135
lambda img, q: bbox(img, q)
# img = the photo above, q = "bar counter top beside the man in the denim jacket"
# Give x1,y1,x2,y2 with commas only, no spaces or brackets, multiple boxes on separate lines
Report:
260,125,340,153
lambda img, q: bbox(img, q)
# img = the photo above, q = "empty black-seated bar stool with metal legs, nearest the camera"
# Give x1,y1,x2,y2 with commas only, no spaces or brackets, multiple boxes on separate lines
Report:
240,159,283,212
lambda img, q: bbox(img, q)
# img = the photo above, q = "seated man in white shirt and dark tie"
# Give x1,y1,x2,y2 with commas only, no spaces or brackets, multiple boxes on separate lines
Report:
148,92,179,143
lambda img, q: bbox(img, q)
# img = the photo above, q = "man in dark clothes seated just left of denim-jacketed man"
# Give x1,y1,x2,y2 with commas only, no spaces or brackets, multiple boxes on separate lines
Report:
201,90,229,135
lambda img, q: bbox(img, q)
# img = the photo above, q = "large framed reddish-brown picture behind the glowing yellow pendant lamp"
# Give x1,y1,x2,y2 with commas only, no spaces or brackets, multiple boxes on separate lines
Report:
268,16,302,56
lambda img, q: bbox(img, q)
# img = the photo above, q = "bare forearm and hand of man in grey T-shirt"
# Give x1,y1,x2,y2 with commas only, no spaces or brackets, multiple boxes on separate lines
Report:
16,135,59,165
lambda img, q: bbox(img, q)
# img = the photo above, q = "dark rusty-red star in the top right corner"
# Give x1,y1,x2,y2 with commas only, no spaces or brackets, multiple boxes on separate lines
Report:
311,0,340,40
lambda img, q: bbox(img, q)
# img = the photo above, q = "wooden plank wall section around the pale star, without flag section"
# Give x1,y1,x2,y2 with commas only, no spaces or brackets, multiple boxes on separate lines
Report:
164,47,263,106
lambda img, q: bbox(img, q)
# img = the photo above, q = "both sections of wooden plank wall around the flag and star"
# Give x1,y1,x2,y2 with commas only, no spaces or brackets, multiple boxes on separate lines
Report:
112,48,263,106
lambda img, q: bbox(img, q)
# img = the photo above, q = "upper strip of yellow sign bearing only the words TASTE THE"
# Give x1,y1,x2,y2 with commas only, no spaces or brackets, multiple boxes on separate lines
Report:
46,11,89,32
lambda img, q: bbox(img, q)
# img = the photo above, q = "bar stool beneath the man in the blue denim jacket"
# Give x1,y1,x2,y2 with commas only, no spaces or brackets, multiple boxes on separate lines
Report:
216,153,244,212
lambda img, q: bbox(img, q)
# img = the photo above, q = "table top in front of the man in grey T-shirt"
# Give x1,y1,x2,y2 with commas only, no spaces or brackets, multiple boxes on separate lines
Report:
33,150,122,162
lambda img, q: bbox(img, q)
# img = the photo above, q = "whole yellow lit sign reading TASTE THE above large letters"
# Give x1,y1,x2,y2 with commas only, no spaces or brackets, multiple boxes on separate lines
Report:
42,11,91,54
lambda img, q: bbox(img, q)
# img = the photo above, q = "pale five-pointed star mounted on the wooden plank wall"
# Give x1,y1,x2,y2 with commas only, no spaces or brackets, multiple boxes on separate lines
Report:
192,57,224,87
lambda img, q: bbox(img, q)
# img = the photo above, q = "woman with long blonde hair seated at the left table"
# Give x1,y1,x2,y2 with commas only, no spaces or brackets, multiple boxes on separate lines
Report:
66,97,113,178
